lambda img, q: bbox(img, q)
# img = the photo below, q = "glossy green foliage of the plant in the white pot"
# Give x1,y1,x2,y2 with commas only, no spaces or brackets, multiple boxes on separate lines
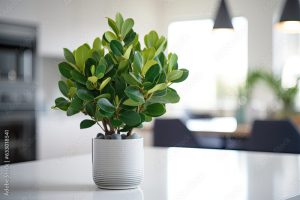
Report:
53,13,188,136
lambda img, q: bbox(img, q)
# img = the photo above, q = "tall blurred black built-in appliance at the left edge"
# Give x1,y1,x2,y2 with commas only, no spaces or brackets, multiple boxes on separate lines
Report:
0,22,37,164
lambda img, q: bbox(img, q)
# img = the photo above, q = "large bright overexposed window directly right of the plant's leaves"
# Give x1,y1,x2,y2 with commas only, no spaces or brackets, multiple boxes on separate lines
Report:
168,17,248,111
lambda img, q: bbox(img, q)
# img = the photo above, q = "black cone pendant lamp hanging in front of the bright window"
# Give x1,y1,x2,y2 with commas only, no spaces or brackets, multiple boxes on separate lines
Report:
213,0,233,30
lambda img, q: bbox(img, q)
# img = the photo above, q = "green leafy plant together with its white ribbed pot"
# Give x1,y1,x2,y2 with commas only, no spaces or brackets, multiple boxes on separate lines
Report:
54,13,188,189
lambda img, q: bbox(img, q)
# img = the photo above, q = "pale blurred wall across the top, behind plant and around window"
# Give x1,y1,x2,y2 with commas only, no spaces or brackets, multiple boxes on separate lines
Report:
0,0,281,67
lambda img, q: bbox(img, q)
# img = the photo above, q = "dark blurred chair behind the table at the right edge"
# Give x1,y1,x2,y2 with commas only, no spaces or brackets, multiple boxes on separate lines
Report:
246,120,300,153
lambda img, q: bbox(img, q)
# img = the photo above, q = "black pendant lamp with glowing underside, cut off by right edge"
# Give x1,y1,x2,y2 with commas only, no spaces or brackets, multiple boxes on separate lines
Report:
276,0,300,33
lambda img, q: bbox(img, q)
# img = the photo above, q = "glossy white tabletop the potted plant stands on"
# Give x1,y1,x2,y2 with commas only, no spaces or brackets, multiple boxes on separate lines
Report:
0,148,300,200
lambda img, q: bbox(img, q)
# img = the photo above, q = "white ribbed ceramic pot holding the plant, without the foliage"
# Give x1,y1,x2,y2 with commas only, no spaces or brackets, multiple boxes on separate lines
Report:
92,138,144,189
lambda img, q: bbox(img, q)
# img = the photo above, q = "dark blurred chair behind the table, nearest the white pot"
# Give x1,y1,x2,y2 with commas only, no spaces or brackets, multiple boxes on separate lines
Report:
153,119,224,149
